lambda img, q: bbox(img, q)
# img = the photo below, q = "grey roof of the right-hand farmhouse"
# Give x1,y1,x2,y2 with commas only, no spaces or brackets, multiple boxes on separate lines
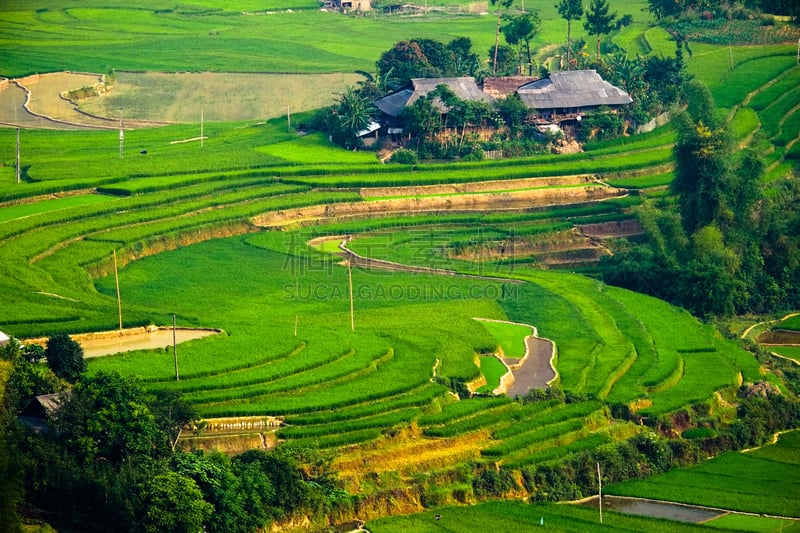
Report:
517,70,633,109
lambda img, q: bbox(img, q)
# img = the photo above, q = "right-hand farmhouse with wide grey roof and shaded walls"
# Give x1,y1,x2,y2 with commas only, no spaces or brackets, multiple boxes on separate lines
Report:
517,70,633,126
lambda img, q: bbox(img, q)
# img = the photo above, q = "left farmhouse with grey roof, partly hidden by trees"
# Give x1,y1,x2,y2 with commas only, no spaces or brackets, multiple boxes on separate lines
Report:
375,76,495,140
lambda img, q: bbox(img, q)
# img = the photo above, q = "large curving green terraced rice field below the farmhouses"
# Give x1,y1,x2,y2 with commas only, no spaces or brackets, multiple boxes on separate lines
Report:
0,23,800,508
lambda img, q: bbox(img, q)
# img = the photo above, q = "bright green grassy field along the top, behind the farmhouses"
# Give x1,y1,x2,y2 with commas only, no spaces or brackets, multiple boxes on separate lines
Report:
0,0,649,77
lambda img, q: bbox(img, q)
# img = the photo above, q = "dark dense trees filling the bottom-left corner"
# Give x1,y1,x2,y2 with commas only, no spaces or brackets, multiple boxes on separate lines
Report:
0,335,350,533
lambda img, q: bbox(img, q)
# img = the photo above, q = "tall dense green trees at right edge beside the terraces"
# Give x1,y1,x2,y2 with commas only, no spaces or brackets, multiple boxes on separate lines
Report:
604,82,800,317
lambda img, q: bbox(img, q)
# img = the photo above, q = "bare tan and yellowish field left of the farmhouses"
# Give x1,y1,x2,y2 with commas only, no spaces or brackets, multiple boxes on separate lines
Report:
0,72,363,129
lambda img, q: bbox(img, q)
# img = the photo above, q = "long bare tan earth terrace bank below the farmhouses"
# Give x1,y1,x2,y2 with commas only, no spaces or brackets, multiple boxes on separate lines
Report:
251,184,626,229
